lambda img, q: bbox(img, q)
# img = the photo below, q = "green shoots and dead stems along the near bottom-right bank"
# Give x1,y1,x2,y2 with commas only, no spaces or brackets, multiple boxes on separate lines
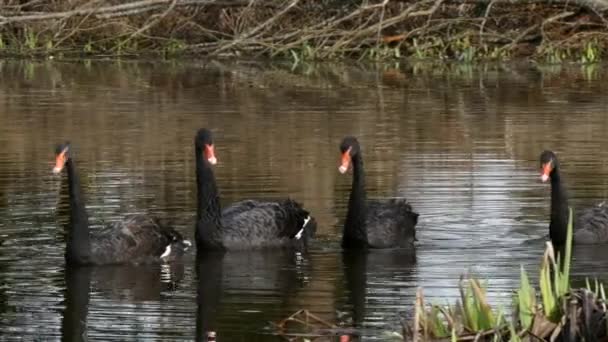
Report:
275,210,608,342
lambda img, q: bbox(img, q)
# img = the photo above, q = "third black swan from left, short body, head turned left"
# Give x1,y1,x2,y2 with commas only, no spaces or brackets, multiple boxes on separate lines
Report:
338,137,418,248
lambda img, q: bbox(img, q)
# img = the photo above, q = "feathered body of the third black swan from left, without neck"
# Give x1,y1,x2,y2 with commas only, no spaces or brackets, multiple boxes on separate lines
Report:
366,199,418,248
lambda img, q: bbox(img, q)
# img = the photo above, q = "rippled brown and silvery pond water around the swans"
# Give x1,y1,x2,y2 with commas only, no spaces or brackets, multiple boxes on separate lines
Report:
0,60,608,341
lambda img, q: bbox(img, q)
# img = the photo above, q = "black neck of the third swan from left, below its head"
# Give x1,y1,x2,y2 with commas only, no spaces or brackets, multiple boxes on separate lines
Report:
342,152,368,247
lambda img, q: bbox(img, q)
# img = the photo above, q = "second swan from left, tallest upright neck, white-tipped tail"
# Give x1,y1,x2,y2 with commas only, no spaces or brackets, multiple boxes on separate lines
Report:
194,128,316,250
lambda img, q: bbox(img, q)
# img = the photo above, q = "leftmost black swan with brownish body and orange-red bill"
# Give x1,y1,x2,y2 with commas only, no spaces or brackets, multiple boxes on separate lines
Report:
53,143,190,265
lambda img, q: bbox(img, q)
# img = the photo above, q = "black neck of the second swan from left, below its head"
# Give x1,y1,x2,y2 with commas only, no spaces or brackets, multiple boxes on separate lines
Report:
195,147,222,228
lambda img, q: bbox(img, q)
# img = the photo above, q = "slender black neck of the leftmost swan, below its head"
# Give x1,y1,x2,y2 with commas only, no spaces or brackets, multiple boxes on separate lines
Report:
66,158,91,264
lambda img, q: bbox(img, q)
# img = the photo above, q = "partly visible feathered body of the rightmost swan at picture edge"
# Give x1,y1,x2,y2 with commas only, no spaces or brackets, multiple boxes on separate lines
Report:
574,204,608,244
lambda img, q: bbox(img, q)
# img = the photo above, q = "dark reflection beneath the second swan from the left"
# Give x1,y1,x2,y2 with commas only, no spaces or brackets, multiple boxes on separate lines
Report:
196,249,312,341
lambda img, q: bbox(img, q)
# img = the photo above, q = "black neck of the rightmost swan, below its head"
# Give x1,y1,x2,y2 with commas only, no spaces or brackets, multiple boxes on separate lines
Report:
549,165,569,246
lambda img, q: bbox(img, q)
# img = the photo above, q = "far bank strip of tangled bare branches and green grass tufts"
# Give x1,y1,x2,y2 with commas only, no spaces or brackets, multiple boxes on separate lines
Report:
0,0,608,63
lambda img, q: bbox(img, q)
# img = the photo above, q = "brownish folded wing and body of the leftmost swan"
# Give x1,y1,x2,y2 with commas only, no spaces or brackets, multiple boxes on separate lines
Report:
91,215,182,263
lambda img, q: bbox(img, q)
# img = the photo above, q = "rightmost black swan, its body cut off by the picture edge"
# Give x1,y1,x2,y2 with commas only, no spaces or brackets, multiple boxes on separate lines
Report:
540,151,608,246
